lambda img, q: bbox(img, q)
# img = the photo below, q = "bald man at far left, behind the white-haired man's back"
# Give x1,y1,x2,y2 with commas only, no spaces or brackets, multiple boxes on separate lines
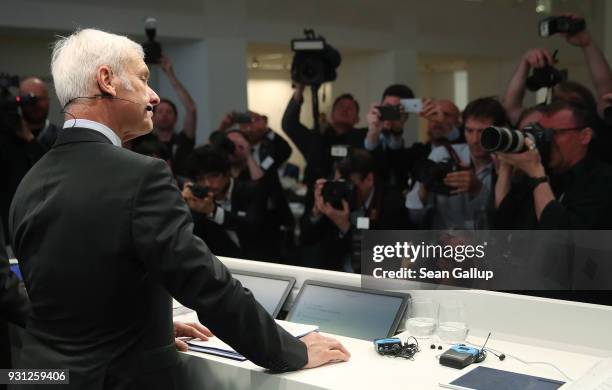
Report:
19,77,59,149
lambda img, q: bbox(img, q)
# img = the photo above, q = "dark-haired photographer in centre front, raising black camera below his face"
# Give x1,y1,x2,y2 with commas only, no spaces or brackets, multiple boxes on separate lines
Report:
301,149,409,272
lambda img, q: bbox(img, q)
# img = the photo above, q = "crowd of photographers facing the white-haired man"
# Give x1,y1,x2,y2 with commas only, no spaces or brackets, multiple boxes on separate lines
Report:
0,14,612,278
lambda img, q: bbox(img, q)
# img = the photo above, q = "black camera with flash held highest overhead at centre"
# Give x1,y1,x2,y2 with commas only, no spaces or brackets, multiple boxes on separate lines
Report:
291,30,342,85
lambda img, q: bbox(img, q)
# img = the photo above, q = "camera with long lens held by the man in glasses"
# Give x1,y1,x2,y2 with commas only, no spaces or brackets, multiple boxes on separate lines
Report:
480,123,554,166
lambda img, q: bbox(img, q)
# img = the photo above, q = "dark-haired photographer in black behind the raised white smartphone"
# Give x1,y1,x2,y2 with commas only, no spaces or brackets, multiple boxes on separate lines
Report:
364,84,418,189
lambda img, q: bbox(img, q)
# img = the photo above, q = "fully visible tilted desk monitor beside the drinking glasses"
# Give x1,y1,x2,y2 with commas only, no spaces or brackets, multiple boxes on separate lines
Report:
287,280,410,341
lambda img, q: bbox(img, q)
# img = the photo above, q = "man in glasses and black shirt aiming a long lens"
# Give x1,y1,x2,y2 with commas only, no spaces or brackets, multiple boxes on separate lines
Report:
496,101,612,230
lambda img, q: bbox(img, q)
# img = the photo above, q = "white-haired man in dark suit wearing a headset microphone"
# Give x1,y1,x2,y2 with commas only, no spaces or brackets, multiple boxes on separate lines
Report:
9,29,349,389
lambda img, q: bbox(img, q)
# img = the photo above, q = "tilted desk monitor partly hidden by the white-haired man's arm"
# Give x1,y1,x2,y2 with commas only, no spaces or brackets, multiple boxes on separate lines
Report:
231,270,295,318
